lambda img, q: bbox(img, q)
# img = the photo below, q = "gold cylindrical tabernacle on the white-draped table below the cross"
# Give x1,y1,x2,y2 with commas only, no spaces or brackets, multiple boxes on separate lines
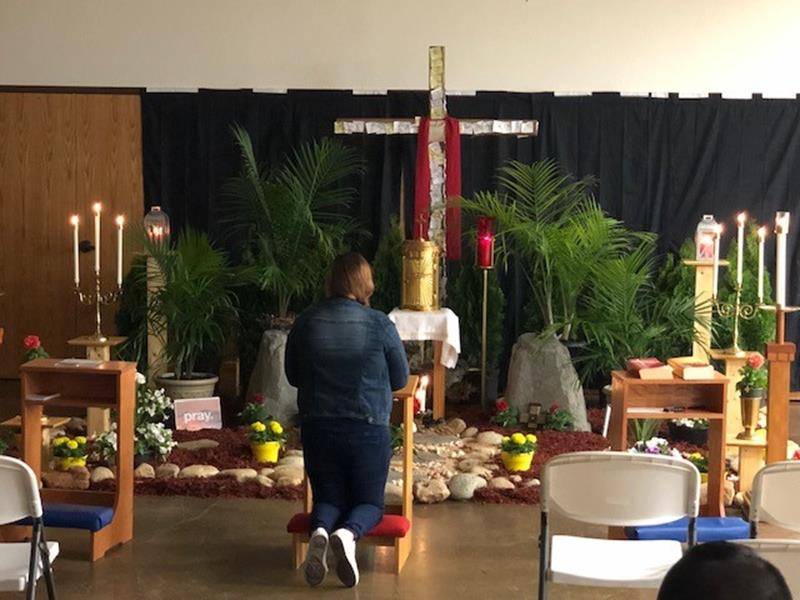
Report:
402,240,439,310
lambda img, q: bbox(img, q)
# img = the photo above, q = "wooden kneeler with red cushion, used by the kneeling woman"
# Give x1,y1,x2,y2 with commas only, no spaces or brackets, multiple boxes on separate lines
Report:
292,375,419,575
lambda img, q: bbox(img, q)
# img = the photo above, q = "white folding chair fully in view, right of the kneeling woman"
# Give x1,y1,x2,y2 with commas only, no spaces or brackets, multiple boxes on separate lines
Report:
539,452,700,600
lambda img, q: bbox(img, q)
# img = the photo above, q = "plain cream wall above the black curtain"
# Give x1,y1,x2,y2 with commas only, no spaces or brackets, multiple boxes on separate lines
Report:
0,0,800,97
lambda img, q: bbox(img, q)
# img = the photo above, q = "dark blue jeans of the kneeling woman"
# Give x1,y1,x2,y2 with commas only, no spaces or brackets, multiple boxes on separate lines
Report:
301,419,392,539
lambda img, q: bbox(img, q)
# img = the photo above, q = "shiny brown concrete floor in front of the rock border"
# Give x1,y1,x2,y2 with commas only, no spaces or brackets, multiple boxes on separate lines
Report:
0,497,655,600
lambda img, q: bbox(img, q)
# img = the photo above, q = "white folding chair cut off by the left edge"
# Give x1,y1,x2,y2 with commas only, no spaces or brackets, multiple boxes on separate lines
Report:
0,456,59,600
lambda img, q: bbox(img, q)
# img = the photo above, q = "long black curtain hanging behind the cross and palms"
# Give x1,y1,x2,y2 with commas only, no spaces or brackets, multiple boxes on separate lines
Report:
142,90,800,386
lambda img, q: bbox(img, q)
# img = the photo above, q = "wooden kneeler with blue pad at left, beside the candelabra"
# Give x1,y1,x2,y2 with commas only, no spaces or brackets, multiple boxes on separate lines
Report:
20,358,136,561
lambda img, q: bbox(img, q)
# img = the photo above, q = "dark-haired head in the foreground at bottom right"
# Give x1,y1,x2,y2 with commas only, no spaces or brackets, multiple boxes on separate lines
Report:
658,542,792,600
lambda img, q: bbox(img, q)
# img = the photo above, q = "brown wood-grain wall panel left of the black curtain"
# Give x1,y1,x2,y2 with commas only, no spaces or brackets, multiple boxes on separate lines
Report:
0,92,143,377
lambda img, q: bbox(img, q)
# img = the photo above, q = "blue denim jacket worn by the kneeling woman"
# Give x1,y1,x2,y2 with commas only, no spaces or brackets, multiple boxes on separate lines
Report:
285,298,409,425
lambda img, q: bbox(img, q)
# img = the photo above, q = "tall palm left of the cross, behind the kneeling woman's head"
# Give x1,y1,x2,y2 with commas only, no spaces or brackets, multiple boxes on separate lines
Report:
222,125,362,318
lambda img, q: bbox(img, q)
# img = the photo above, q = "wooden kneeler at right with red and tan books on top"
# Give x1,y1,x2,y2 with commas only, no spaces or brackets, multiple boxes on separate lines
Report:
608,371,729,517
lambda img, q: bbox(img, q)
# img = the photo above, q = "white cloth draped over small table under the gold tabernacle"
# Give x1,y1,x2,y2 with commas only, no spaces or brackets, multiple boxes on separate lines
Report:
389,308,461,369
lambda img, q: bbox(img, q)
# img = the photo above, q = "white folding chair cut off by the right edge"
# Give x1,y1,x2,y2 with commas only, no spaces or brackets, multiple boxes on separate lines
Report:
739,461,800,598
